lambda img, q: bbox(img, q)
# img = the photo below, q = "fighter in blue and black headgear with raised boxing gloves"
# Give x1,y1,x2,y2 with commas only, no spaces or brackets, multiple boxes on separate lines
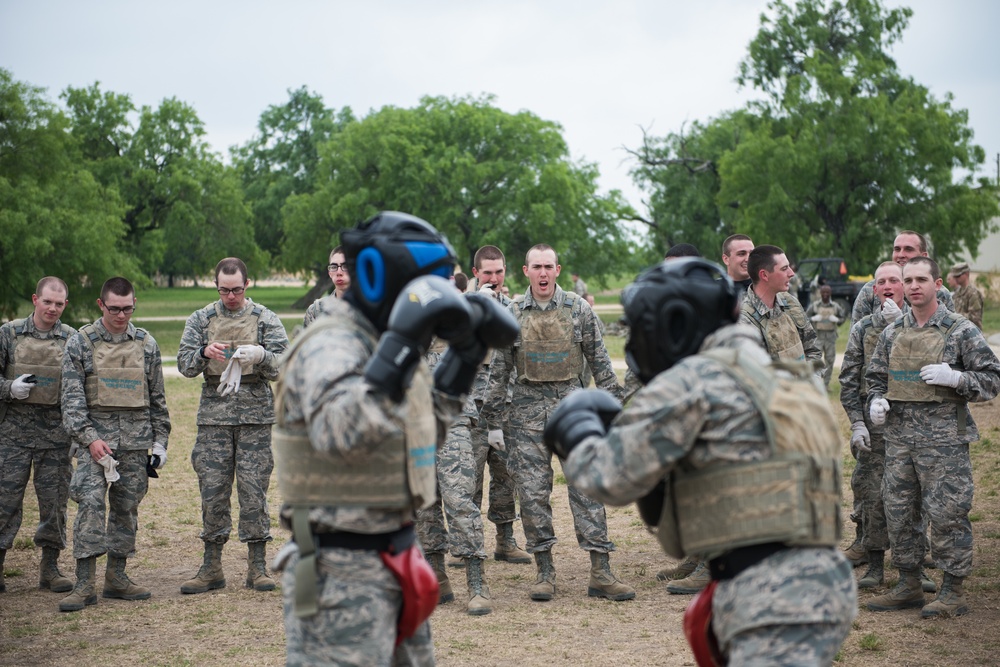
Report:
274,212,515,665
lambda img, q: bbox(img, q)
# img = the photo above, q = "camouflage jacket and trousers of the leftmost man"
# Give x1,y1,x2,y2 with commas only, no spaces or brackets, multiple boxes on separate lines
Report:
0,315,76,552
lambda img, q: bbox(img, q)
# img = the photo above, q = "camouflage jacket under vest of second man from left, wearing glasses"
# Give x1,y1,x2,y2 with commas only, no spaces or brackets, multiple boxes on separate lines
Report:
62,320,170,450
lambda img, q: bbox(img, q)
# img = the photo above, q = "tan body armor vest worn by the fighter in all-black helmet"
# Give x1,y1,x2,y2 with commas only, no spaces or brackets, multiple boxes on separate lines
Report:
657,350,841,558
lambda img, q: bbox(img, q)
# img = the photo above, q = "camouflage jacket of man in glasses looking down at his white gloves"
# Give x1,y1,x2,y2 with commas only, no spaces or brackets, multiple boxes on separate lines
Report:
177,298,288,426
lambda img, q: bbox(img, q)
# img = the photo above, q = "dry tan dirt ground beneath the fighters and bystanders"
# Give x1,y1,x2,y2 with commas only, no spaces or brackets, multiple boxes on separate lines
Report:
0,378,1000,667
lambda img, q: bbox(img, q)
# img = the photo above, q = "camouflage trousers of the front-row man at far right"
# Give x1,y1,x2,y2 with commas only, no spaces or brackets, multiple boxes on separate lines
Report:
882,438,973,577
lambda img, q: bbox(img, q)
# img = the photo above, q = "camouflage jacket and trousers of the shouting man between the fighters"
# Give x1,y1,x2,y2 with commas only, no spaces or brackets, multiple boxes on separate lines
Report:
482,286,622,554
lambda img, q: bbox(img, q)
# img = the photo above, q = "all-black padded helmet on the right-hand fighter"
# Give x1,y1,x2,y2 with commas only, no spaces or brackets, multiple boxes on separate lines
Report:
622,257,739,383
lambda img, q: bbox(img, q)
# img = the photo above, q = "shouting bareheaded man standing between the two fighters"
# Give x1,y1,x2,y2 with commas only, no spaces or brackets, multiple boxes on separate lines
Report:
481,245,635,600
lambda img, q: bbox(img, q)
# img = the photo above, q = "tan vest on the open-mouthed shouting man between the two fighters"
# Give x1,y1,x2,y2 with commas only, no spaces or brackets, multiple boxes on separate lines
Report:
515,295,583,382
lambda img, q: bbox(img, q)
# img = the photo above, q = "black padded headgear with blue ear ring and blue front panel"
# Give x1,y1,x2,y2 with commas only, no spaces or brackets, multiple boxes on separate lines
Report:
340,211,456,331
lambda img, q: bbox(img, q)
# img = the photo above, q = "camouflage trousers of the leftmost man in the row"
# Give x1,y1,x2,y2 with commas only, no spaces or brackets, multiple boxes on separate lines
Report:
0,443,73,549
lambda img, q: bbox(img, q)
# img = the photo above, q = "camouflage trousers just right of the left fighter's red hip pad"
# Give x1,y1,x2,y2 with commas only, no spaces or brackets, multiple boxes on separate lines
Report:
416,416,486,558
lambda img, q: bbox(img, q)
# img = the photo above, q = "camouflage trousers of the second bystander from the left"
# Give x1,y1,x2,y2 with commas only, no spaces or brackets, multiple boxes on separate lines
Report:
69,447,149,560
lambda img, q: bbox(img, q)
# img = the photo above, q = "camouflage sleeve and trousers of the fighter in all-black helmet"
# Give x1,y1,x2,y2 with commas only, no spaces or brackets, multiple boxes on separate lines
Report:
563,326,857,665
